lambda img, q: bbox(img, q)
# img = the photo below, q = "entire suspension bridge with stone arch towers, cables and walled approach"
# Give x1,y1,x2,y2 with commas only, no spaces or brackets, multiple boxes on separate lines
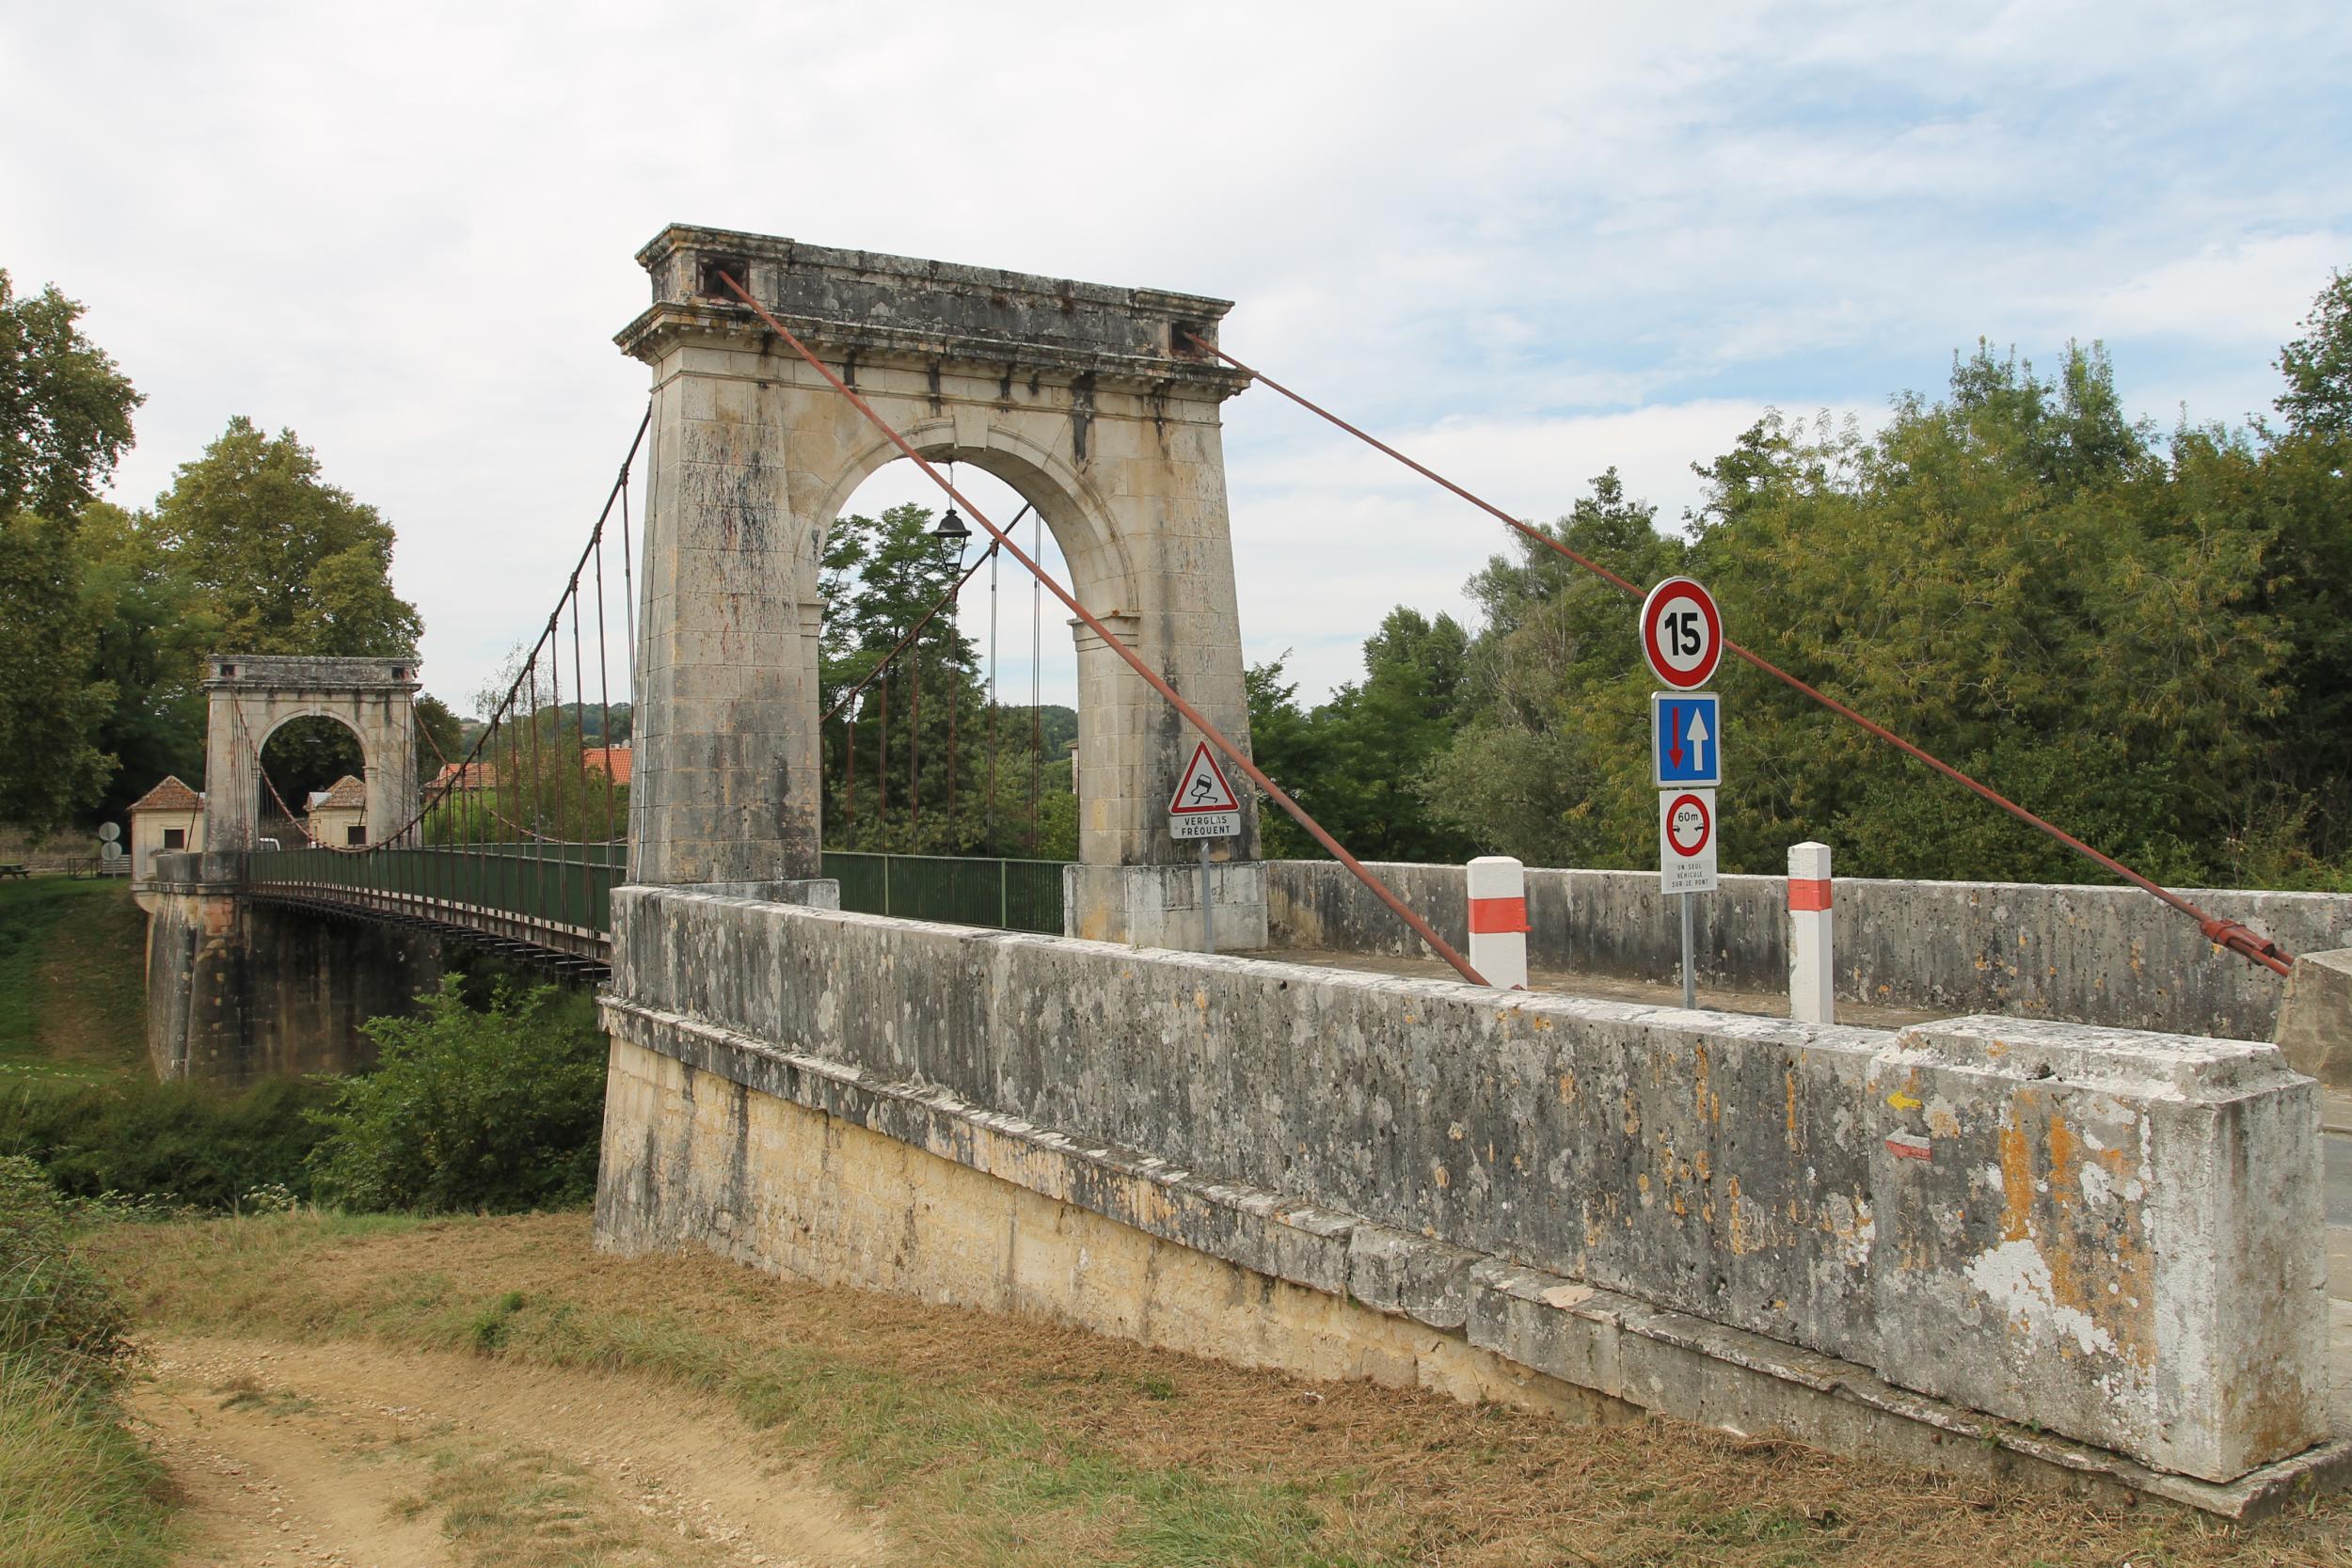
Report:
141,226,2352,1514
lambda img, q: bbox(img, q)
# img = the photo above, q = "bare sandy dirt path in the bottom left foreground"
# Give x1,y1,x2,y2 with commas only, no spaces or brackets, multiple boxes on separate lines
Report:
135,1338,889,1568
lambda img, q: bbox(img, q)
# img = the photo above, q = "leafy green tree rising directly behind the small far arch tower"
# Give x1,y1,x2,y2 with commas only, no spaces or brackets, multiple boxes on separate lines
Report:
155,414,423,658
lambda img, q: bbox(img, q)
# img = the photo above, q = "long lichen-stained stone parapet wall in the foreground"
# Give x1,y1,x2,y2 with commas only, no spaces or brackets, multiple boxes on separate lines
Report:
600,889,2327,1481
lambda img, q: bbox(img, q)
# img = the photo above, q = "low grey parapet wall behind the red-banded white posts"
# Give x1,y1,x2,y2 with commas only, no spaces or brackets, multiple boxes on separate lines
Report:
1268,861,2352,1039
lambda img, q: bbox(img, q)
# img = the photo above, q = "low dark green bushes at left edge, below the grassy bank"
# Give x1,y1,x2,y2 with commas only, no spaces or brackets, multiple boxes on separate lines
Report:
0,1079,334,1209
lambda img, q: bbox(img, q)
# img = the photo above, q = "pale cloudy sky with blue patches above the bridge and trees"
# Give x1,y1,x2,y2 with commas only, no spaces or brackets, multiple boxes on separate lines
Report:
0,0,2352,714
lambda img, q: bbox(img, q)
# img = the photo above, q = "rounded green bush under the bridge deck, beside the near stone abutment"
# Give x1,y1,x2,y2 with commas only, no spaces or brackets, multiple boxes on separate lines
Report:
310,975,605,1213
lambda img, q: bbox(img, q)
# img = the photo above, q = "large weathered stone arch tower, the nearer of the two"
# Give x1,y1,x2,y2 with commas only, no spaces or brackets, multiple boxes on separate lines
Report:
619,226,1265,947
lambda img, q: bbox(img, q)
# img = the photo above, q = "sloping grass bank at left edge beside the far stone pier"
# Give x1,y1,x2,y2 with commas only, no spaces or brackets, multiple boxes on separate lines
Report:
0,877,146,1084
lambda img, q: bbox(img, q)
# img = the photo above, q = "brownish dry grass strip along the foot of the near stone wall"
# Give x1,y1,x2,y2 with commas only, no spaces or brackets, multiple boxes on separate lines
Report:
87,1215,2352,1568
